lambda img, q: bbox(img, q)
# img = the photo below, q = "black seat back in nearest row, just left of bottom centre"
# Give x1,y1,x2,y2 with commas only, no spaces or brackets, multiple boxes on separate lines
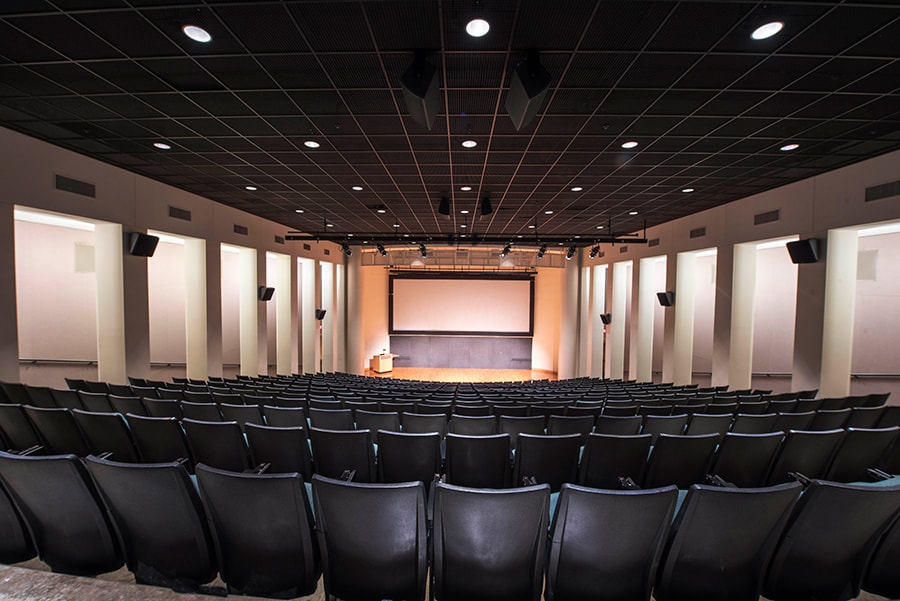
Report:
312,475,426,601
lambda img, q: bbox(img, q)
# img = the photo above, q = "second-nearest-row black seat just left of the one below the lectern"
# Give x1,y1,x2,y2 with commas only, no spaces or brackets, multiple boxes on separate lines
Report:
309,426,377,482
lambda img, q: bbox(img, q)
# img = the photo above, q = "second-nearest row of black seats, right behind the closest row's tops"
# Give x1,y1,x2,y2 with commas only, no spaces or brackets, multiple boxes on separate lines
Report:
7,401,900,491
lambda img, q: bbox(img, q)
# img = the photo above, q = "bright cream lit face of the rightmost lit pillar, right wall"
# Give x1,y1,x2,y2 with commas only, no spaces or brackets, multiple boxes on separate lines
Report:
819,230,859,398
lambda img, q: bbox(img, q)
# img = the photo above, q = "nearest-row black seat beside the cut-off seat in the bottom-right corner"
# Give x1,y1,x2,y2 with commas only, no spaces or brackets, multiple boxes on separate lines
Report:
763,480,900,601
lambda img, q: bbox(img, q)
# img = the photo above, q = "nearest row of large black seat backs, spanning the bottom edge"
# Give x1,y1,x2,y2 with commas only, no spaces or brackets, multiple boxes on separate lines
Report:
0,453,900,601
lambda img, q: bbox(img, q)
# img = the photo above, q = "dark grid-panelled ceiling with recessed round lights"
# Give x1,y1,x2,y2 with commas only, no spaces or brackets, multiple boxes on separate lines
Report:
0,0,900,246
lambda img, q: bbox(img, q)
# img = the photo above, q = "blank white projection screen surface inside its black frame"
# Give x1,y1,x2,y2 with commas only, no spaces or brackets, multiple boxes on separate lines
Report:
391,277,532,335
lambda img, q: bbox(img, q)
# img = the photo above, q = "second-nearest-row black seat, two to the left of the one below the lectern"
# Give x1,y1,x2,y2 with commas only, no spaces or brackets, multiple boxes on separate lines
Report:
244,423,312,481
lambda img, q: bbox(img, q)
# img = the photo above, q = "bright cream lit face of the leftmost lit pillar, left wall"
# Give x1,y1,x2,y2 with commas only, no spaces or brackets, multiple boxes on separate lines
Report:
94,223,127,384
